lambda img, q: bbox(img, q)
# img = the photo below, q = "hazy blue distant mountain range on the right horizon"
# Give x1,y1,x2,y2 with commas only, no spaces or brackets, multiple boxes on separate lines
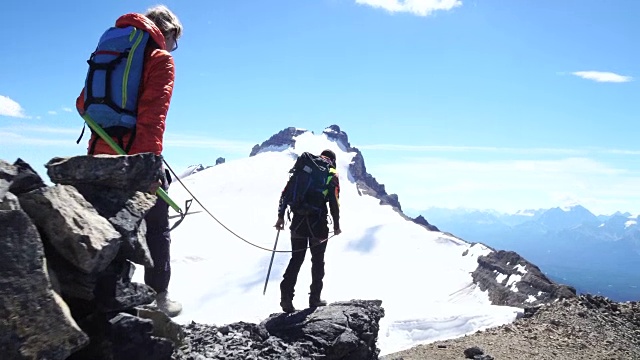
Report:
419,205,640,301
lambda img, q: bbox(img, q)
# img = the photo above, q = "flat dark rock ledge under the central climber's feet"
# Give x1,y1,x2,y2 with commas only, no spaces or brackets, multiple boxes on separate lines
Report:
174,300,384,360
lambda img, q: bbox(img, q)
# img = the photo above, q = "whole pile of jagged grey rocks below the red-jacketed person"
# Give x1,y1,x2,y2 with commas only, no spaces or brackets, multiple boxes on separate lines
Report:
0,154,177,360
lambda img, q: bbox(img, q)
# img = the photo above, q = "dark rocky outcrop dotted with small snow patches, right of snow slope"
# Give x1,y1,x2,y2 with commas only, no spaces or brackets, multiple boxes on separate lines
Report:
472,250,576,307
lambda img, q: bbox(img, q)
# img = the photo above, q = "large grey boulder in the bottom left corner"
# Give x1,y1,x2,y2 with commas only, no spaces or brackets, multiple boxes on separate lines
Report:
0,210,89,359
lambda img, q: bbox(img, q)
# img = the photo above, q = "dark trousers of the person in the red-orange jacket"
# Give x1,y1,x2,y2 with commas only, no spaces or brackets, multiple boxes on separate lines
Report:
144,185,171,293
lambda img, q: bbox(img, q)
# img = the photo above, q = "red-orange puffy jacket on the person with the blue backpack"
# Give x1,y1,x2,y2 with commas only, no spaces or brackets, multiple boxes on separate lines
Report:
76,14,174,155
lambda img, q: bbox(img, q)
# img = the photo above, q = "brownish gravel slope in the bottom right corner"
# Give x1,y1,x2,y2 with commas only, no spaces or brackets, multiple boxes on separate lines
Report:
380,295,640,360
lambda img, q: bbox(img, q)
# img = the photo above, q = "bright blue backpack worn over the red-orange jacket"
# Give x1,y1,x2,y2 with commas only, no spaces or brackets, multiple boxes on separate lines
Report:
77,26,149,154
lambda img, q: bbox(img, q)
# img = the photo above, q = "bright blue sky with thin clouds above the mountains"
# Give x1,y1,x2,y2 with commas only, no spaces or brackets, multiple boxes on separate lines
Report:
0,0,640,213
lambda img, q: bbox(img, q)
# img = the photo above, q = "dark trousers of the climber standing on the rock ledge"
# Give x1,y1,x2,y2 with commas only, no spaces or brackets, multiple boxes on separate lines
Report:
280,215,329,299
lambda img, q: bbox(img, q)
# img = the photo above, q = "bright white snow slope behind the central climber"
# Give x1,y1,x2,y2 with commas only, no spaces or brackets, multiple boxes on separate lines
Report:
134,132,521,355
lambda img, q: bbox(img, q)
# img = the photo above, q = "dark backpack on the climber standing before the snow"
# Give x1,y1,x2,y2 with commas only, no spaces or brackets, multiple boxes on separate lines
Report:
283,152,333,215
